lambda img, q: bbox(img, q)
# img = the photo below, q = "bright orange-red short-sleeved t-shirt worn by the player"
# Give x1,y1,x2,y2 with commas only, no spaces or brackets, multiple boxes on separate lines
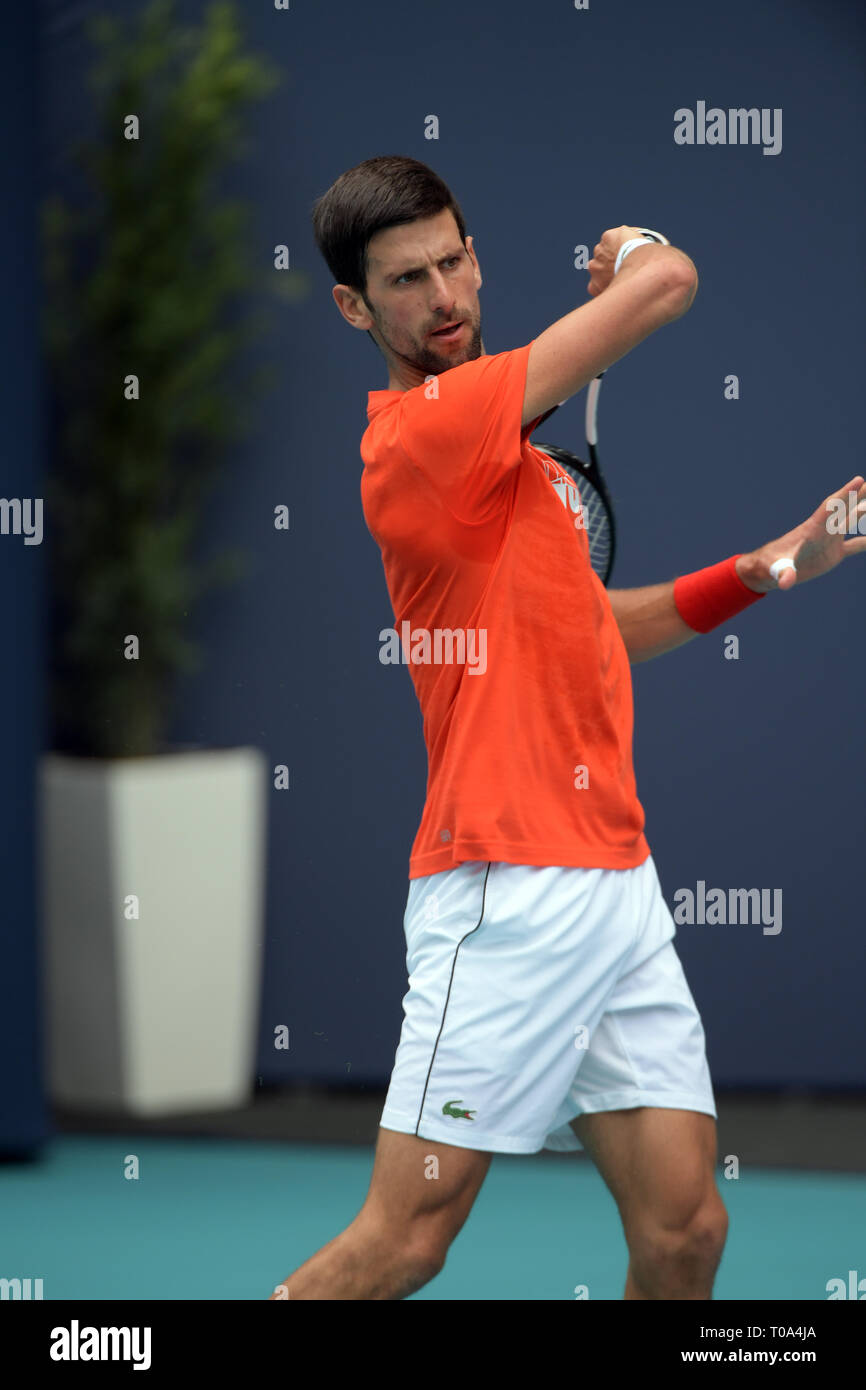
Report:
361,343,649,878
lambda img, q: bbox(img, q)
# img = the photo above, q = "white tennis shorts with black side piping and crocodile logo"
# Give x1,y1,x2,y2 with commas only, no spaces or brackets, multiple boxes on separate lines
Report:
379,855,716,1154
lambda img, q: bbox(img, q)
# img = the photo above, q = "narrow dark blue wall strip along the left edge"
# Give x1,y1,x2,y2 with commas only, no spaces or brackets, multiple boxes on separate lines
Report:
0,6,47,1154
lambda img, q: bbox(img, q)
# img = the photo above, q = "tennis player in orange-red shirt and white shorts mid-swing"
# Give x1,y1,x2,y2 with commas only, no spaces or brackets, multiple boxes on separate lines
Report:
271,156,866,1300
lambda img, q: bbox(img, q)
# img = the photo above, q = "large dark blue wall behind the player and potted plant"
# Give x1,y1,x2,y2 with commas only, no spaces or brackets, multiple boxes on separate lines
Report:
23,0,866,1134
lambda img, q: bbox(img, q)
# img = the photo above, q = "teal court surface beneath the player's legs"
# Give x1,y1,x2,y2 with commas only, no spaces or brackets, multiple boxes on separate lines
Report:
0,1134,866,1301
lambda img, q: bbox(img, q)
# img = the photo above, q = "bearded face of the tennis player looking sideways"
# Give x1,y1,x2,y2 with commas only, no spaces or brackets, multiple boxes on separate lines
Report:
334,209,484,391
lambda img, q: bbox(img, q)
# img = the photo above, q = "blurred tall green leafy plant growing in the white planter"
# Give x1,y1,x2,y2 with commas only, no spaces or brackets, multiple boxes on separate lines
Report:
43,0,303,758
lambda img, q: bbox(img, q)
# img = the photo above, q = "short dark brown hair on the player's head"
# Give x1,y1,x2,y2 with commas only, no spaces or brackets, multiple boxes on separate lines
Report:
313,154,466,297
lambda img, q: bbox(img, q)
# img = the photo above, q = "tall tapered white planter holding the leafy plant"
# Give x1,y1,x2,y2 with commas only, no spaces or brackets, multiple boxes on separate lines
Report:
39,748,267,1116
